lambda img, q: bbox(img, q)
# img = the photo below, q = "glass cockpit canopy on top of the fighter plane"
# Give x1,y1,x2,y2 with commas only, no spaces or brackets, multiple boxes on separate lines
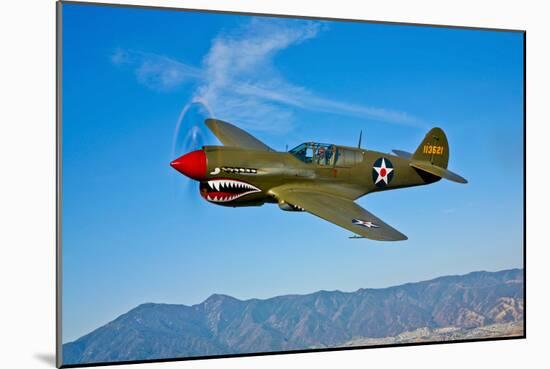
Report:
289,142,363,166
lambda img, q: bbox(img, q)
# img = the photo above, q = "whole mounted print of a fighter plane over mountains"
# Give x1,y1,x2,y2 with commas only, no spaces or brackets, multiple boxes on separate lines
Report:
57,2,525,367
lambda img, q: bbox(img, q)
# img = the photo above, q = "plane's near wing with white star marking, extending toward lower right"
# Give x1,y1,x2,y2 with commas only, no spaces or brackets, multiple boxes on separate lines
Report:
271,187,407,241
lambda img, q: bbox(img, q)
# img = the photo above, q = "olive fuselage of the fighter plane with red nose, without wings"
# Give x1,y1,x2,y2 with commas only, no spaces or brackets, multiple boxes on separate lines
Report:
172,143,440,210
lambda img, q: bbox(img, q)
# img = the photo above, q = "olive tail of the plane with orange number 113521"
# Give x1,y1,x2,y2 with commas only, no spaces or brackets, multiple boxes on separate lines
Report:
410,127,468,183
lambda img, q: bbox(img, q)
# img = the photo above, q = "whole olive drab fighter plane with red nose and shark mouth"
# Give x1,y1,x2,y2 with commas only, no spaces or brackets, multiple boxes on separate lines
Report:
170,119,467,241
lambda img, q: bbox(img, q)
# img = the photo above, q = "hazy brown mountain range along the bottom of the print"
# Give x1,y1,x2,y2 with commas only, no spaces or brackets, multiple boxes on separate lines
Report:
63,269,524,365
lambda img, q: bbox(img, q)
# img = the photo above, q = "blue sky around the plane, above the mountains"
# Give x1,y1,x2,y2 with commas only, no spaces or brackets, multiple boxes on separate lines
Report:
62,4,523,342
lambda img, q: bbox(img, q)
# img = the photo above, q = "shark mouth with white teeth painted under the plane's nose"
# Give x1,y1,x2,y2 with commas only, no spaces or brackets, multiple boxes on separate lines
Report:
200,179,261,202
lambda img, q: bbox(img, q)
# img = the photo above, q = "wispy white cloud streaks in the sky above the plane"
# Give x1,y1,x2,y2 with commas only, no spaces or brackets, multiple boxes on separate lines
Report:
112,18,422,135
